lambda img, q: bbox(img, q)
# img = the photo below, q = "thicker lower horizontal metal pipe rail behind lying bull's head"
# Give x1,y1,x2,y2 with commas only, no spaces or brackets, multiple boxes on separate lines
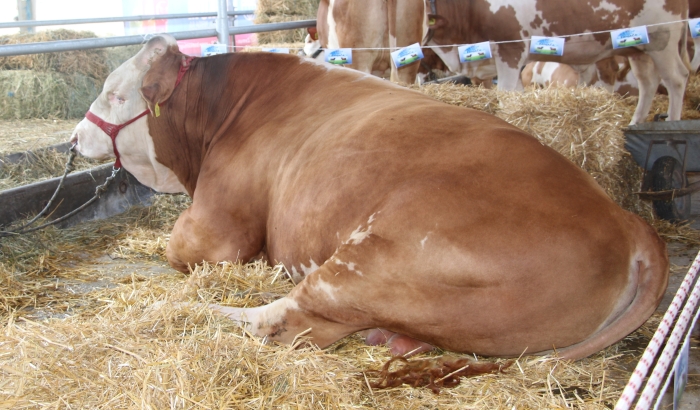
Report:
0,20,316,57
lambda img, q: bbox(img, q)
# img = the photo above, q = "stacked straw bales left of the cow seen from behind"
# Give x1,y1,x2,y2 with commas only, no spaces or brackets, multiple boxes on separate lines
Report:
255,0,319,44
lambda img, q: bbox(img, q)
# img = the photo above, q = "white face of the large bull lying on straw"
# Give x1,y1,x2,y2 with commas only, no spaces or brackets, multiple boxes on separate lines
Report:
70,35,185,193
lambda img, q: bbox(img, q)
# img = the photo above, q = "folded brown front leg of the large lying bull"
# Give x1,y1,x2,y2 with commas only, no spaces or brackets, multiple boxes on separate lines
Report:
165,203,265,273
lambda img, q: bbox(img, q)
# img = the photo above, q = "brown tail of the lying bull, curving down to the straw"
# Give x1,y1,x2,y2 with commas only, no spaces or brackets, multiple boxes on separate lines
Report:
558,214,669,359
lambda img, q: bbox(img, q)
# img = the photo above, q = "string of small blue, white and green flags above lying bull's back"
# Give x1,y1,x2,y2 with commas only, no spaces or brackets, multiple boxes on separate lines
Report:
206,18,700,68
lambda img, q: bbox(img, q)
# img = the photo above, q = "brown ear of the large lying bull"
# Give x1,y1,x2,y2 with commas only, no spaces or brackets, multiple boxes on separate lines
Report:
140,51,187,115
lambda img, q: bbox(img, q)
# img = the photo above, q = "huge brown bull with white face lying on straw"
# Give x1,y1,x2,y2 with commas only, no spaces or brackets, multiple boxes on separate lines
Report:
71,36,669,358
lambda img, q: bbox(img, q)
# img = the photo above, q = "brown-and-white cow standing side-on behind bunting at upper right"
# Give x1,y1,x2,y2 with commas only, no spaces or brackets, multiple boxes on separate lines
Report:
427,0,688,124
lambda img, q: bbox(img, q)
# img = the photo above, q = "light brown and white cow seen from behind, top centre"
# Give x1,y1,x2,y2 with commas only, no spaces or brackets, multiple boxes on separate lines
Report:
316,0,428,84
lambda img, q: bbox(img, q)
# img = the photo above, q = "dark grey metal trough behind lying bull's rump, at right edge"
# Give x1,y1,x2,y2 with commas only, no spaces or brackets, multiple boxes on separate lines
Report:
624,120,700,221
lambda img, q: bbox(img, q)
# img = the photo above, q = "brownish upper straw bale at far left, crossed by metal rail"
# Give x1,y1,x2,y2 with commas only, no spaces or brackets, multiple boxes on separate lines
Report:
0,29,110,82
